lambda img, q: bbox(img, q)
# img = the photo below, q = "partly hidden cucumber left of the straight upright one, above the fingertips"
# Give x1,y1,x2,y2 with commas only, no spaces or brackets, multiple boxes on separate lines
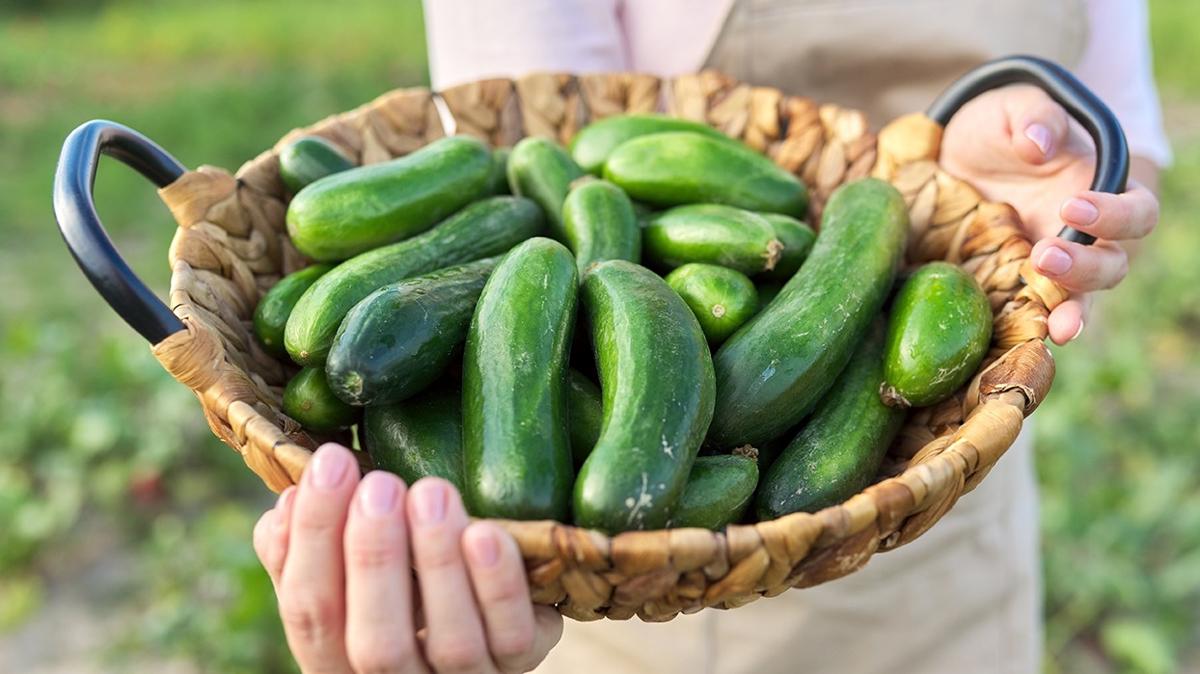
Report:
361,385,464,491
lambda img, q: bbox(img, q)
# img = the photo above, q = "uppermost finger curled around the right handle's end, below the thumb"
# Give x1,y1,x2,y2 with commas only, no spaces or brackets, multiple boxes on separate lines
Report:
1060,182,1158,241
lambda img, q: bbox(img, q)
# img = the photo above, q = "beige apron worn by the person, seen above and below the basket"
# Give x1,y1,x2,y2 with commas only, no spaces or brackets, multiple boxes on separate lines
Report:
536,0,1087,674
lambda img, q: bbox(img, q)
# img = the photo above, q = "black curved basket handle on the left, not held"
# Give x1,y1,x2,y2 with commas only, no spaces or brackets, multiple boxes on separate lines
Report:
54,120,187,344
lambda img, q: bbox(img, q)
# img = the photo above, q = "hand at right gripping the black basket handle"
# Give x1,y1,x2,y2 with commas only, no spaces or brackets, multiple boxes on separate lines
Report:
941,85,1158,344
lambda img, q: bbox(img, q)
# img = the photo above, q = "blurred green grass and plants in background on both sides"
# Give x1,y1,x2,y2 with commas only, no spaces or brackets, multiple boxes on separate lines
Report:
0,0,1200,673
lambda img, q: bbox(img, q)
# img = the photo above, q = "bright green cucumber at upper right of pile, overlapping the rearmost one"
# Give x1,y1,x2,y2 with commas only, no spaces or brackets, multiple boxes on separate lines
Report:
604,132,809,217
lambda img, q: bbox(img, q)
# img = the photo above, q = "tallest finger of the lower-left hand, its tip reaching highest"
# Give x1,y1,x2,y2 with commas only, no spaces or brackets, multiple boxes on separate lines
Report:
280,444,359,672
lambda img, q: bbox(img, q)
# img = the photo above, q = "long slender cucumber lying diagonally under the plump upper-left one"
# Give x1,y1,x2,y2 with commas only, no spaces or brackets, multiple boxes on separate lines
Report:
283,197,545,365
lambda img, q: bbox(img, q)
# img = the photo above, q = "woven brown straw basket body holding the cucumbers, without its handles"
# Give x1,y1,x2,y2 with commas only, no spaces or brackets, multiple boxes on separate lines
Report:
152,72,1066,621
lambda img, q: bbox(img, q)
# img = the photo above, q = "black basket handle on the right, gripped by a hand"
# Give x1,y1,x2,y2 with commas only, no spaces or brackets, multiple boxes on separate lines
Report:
925,56,1129,246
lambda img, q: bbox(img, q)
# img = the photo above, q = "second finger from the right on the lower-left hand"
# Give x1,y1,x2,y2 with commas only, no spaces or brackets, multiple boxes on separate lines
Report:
406,477,493,674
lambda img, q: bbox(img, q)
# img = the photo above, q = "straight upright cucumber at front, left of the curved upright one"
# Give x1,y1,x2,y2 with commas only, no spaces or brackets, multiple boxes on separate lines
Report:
462,237,578,520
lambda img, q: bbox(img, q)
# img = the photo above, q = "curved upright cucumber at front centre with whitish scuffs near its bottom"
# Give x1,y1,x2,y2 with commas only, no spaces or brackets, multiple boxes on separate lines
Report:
575,260,715,534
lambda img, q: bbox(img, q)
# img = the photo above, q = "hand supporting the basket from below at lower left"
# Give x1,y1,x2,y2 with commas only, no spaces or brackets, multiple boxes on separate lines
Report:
254,445,563,673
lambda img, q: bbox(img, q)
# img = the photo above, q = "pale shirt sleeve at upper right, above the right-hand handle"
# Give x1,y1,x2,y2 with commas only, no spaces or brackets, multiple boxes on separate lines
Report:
1075,0,1171,167
